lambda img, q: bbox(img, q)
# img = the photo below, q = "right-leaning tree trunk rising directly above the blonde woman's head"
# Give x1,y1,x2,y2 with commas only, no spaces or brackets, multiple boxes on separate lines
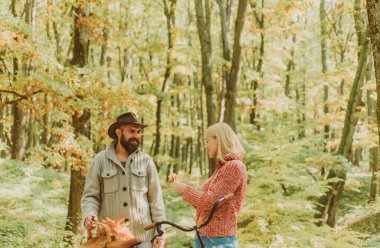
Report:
224,0,247,130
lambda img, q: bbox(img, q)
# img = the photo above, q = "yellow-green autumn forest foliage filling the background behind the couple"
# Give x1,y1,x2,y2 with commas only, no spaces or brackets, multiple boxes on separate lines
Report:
0,0,380,247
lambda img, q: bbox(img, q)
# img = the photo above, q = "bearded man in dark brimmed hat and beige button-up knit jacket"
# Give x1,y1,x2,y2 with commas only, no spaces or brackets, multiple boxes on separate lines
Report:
81,112,165,248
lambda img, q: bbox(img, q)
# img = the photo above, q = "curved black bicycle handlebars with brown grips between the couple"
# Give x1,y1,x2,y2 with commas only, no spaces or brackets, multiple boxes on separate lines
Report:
144,193,234,248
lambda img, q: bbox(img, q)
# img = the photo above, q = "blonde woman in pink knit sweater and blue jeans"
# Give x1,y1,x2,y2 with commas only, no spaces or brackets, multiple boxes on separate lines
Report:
171,123,247,248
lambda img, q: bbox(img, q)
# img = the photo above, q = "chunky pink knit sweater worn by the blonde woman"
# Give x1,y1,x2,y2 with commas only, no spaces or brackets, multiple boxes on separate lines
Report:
183,153,247,237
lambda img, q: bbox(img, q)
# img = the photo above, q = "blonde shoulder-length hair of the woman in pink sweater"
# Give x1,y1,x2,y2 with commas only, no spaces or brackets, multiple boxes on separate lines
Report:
205,122,245,163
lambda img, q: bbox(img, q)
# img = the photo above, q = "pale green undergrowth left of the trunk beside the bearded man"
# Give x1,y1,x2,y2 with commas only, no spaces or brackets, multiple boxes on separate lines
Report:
0,159,70,247
